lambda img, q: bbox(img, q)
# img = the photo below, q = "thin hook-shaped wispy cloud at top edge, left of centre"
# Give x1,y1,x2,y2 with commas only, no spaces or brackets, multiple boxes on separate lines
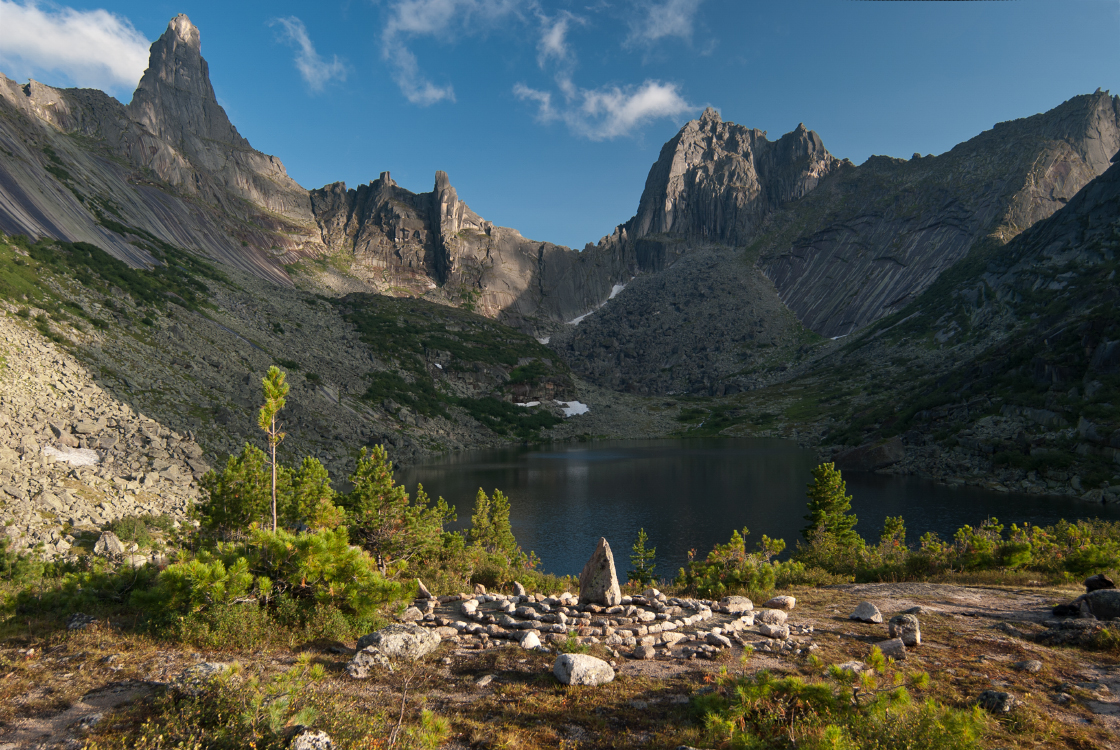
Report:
381,0,524,106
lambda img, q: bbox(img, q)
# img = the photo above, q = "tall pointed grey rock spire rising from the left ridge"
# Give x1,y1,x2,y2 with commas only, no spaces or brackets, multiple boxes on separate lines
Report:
129,13,250,151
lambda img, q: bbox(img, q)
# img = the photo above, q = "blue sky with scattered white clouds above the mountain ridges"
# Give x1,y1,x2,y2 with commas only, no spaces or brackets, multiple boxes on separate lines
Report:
0,0,1120,247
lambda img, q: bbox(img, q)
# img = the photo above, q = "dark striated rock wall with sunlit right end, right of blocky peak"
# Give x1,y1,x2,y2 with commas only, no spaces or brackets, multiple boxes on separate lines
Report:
758,92,1120,336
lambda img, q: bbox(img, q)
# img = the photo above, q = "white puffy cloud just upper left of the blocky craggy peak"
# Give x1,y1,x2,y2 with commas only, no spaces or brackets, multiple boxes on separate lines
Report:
513,76,697,141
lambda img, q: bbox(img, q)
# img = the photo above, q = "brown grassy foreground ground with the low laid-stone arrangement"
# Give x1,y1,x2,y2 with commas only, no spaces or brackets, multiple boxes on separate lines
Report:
0,583,1120,750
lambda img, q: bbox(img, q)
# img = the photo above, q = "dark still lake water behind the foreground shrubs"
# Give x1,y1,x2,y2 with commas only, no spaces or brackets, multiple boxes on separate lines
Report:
398,439,1120,578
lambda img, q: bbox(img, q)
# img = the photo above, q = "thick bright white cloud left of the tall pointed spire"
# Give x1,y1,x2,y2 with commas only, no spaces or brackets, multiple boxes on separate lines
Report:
0,0,151,93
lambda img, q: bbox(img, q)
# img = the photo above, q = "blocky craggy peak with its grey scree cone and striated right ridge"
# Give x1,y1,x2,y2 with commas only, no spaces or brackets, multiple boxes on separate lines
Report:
552,92,1120,395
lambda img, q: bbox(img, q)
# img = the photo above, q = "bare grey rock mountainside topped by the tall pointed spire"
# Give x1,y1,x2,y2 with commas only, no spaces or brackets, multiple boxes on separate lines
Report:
0,16,321,284
